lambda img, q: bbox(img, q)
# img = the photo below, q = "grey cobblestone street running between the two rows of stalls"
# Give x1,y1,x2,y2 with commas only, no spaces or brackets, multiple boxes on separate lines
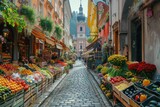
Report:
41,61,110,107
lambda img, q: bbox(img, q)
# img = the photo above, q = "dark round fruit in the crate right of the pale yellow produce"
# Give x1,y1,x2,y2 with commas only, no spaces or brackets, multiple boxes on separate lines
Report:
123,85,140,98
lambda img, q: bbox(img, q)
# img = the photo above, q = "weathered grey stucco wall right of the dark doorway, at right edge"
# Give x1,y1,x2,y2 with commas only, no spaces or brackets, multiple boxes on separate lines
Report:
145,3,160,73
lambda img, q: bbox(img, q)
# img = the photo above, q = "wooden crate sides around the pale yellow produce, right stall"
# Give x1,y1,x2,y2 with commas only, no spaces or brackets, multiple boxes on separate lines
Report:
112,80,132,96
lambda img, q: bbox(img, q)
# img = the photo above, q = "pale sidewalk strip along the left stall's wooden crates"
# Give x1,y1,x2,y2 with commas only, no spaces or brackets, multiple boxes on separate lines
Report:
31,73,67,107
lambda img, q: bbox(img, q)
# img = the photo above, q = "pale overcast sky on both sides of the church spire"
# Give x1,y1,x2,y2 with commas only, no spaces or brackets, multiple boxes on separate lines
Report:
69,0,88,17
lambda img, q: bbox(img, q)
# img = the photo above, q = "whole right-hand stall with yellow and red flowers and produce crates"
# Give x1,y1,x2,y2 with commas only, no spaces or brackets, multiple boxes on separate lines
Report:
96,55,160,107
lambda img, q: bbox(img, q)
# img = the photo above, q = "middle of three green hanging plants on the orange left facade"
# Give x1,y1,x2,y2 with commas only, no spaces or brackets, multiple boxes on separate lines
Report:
40,18,53,33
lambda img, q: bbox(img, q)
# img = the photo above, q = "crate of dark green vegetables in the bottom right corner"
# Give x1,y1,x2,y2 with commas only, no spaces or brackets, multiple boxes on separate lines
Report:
141,96,160,107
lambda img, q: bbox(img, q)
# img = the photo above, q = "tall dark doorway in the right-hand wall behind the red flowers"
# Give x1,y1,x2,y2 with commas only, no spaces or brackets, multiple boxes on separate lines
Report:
131,18,142,62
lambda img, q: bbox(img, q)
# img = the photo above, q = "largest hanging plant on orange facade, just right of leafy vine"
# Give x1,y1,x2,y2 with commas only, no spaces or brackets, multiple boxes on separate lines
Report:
20,5,35,24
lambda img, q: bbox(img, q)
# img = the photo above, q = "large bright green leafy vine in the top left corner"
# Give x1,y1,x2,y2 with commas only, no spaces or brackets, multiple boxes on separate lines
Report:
0,0,26,32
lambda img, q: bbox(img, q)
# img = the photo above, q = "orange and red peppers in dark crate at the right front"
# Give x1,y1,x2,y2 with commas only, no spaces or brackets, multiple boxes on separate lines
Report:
132,90,150,103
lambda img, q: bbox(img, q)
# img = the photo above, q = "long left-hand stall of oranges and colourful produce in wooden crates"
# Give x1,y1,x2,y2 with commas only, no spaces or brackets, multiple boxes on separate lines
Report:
0,58,74,107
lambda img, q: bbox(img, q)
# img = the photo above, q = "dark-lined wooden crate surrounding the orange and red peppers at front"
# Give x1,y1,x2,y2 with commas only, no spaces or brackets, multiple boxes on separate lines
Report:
130,90,151,107
